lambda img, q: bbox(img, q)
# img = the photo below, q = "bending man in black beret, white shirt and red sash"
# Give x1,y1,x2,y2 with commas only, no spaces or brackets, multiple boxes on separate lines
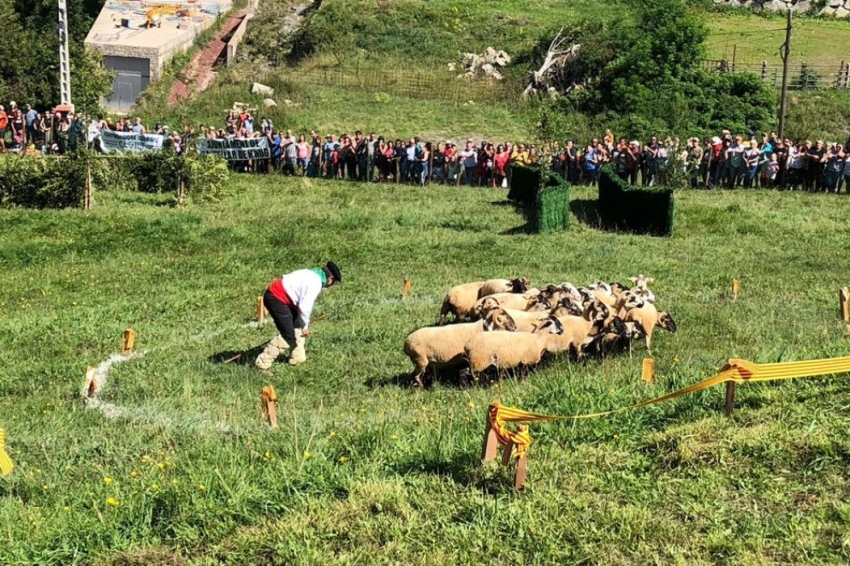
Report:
254,261,342,375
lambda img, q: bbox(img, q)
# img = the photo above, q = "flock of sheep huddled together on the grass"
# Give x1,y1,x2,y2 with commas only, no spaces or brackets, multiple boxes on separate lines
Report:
404,275,676,387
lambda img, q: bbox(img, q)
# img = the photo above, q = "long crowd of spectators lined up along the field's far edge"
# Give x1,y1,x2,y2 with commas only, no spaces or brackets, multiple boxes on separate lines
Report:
8,102,850,193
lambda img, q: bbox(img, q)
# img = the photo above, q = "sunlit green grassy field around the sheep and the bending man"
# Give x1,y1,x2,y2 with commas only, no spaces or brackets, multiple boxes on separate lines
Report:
0,177,850,566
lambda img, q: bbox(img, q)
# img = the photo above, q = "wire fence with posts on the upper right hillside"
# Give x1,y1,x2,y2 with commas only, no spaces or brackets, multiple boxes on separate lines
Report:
700,59,850,90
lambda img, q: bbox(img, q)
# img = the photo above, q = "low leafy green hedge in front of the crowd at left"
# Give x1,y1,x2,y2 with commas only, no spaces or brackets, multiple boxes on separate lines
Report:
0,152,229,208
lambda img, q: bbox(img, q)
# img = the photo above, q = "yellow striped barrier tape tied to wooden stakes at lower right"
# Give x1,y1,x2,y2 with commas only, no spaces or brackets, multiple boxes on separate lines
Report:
487,357,850,457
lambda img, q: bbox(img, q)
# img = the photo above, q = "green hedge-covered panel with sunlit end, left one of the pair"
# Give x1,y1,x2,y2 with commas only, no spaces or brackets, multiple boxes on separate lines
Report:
508,165,570,232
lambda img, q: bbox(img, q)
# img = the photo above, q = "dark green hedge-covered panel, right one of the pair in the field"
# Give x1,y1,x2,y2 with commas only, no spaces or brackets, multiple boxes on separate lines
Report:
599,165,674,236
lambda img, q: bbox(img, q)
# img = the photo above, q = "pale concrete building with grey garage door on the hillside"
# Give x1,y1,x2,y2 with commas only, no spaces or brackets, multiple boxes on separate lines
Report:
85,0,231,112
